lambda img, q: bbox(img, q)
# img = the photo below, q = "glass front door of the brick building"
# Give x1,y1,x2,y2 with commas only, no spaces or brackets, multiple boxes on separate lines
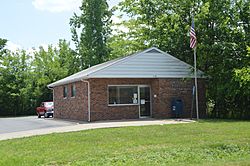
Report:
139,86,151,117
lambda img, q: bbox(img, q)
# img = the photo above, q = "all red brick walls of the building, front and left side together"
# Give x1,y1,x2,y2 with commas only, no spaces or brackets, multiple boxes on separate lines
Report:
54,78,206,121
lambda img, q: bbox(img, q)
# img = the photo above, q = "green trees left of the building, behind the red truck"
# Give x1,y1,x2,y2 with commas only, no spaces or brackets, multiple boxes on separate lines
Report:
0,40,79,116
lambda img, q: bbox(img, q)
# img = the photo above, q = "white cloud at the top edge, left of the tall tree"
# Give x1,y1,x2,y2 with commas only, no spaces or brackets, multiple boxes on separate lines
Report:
32,0,81,13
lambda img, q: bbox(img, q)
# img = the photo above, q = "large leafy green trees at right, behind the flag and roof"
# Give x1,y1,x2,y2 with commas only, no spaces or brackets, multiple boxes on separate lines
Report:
114,0,250,118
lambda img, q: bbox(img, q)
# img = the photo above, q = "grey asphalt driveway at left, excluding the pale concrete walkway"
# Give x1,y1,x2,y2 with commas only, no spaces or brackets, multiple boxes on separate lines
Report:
0,116,76,134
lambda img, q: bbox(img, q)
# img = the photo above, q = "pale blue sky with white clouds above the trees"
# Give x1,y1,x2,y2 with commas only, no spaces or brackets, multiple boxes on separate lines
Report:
0,0,121,50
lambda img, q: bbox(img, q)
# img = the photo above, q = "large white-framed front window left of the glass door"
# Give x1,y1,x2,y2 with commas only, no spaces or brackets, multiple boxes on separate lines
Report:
108,86,138,105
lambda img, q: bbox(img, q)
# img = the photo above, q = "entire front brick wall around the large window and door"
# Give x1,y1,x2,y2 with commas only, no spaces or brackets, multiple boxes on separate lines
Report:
90,79,206,121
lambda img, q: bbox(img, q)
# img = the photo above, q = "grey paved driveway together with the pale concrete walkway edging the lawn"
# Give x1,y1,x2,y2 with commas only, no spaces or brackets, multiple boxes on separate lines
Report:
0,117,194,141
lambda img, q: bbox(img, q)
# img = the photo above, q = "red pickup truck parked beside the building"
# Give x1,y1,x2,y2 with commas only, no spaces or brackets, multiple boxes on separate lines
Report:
36,101,54,118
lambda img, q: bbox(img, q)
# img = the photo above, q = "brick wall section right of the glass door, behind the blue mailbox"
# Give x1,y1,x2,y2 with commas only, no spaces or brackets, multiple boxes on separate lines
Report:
153,79,206,118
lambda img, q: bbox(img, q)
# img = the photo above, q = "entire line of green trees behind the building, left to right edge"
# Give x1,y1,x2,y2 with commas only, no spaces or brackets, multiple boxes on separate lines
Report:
0,0,250,118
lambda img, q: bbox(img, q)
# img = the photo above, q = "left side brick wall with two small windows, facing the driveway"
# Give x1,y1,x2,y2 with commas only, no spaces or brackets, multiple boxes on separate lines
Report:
54,82,88,121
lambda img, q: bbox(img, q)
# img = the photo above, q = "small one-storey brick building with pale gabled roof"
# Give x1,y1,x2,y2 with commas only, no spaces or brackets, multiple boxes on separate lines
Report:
48,47,206,121
